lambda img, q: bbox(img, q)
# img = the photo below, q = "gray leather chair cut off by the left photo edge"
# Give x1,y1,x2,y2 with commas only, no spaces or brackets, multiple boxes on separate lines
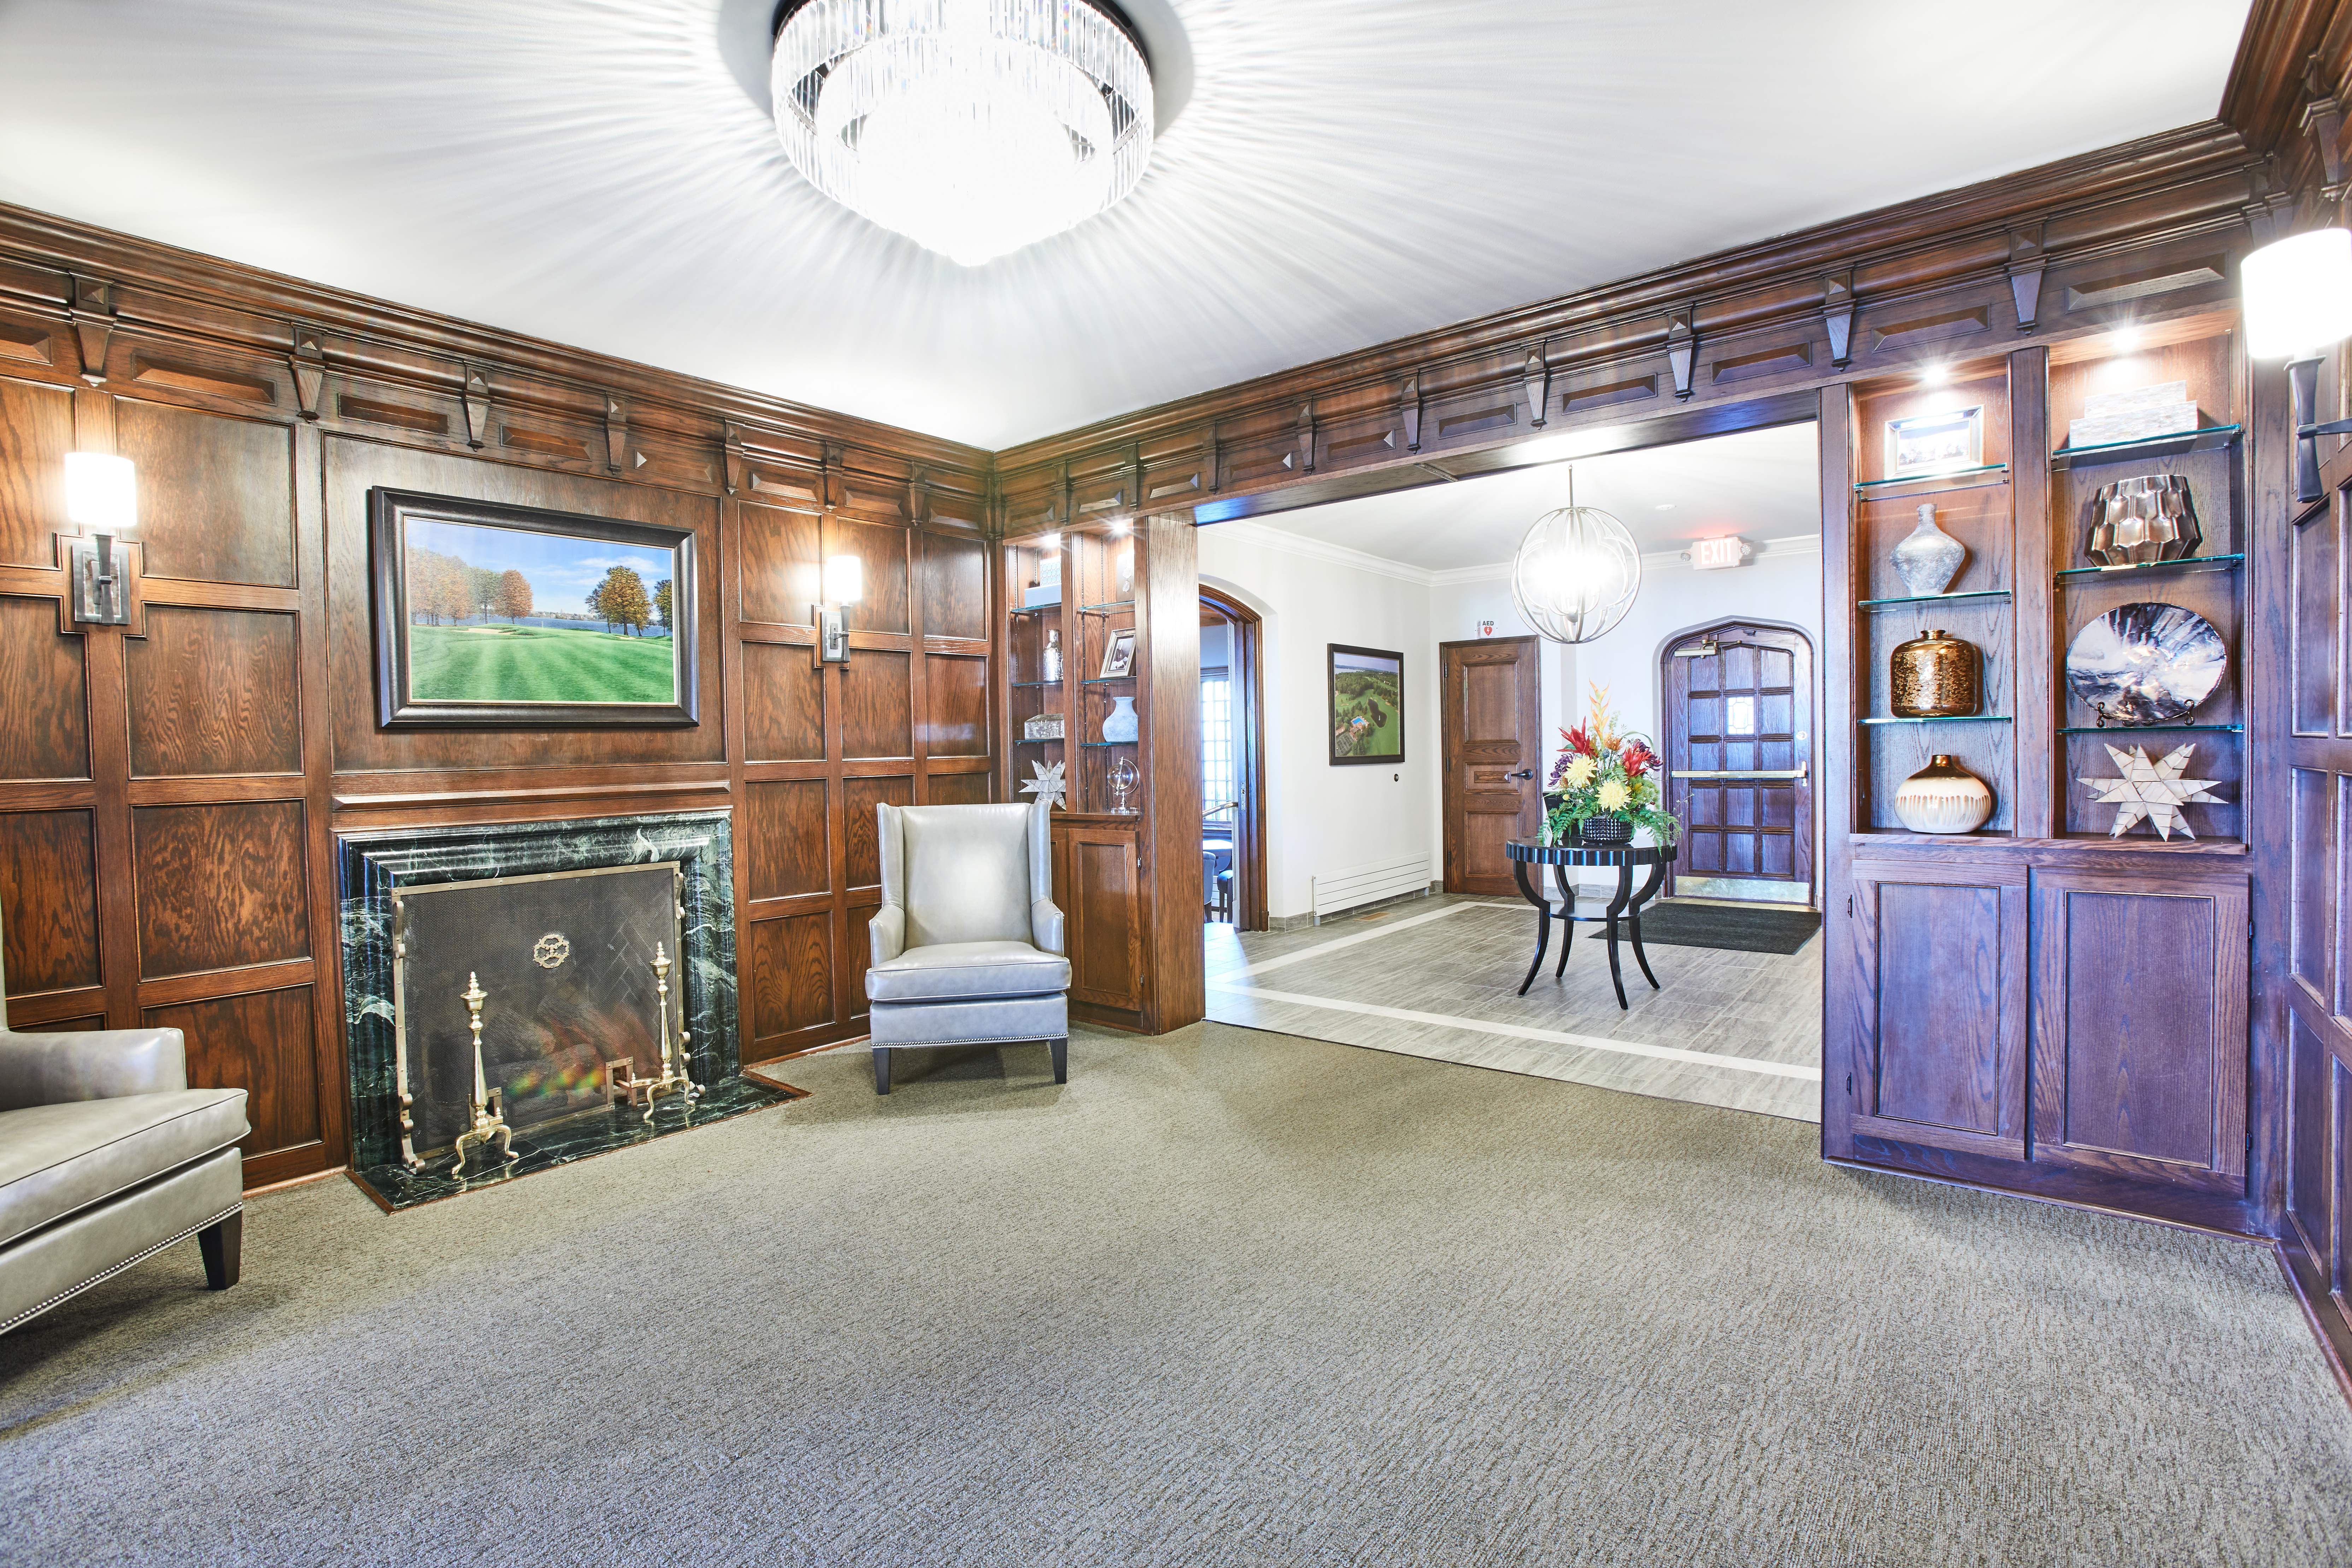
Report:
0,907,252,1333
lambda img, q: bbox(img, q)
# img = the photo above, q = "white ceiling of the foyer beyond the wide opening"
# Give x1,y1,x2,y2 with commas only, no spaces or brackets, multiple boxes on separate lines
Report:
1242,421,1821,571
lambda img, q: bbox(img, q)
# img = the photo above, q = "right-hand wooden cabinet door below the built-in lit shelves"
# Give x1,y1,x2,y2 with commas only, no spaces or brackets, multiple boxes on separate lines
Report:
2032,870,2248,1192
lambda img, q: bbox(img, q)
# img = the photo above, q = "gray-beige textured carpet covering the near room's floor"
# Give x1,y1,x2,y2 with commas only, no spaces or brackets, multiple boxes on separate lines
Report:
0,1025,2352,1568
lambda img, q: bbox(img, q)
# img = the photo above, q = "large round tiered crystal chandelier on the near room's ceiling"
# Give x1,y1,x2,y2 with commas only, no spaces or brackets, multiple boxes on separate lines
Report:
769,0,1152,266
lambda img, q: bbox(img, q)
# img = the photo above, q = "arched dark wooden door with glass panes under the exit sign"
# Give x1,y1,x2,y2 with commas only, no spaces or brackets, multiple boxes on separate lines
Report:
1658,621,1813,903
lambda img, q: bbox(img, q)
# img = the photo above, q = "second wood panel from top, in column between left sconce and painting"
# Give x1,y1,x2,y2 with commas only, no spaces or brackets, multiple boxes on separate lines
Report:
122,604,301,778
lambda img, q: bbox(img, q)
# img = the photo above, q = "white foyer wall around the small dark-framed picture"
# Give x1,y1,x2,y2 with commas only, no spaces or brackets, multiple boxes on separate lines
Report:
1200,522,1439,917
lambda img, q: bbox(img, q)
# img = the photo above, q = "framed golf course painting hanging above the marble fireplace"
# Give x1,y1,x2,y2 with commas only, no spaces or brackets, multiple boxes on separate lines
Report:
367,489,699,729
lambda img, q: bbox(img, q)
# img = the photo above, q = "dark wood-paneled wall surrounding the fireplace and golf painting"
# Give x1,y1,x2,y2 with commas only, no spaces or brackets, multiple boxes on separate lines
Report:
0,209,993,1185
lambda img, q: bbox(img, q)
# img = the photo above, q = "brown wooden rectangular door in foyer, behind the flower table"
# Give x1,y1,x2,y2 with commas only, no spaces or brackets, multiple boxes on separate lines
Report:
1437,637,1543,893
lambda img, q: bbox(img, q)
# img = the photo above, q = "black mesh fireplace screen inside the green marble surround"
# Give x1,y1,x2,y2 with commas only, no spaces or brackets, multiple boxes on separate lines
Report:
393,861,684,1157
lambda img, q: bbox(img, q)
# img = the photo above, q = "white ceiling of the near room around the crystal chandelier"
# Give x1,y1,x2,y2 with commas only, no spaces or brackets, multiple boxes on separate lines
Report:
0,0,2246,447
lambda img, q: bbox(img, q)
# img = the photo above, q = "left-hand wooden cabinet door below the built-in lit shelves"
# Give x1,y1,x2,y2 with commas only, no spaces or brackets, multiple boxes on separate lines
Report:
1851,861,2027,1159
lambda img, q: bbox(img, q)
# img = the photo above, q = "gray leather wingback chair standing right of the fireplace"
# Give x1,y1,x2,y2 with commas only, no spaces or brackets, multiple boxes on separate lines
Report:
865,801,1070,1096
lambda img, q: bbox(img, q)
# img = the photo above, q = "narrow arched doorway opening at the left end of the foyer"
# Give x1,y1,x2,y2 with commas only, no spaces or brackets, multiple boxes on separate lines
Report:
1200,588,1265,931
